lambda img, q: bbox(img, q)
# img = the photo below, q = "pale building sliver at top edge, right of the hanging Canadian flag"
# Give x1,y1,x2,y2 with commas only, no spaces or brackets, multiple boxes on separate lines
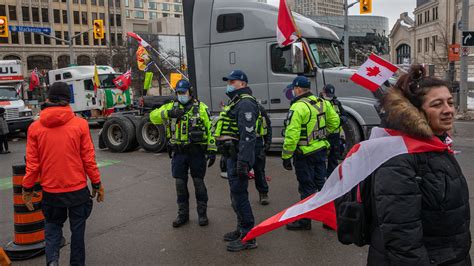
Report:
287,0,344,17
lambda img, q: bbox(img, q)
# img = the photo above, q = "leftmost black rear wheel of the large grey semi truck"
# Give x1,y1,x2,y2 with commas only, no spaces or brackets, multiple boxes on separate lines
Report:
102,117,136,152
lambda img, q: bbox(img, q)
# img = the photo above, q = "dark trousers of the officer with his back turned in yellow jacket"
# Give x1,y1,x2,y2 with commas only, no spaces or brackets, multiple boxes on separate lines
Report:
293,149,327,199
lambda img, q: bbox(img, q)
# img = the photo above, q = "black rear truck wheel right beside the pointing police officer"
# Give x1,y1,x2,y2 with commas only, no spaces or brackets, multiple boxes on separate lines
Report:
136,114,166,153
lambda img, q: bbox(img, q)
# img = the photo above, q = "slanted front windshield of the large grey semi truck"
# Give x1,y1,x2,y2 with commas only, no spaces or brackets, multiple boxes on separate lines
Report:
308,39,342,68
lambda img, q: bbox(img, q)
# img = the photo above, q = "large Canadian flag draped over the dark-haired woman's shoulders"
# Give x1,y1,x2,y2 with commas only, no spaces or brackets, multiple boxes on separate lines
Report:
243,127,452,241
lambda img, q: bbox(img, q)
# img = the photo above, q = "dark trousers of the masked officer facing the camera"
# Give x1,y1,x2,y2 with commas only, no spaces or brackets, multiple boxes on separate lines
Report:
171,151,208,215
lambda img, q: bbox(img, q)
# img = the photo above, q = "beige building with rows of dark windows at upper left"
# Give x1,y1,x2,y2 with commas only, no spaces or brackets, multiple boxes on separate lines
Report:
0,0,125,73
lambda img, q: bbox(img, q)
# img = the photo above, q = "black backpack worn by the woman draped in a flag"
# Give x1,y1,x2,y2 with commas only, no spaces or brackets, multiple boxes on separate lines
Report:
334,153,428,247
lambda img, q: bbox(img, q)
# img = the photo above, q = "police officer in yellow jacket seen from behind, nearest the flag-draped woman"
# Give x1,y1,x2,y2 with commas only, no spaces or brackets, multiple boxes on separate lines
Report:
282,76,339,230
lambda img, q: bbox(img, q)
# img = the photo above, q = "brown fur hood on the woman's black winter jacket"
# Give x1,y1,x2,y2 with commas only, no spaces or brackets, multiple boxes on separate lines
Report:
382,88,434,139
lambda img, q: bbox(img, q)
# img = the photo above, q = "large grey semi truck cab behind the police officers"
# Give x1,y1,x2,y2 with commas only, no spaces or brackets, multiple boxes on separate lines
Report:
183,0,380,150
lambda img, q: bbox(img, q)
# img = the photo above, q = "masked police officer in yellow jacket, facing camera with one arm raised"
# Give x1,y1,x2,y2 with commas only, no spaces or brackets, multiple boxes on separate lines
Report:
150,79,217,227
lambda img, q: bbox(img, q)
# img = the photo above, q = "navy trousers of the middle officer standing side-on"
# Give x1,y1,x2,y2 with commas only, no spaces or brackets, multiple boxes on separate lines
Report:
227,158,255,235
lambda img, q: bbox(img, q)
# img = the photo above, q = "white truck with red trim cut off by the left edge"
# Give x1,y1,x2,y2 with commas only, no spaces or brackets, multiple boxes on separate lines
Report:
0,60,33,133
